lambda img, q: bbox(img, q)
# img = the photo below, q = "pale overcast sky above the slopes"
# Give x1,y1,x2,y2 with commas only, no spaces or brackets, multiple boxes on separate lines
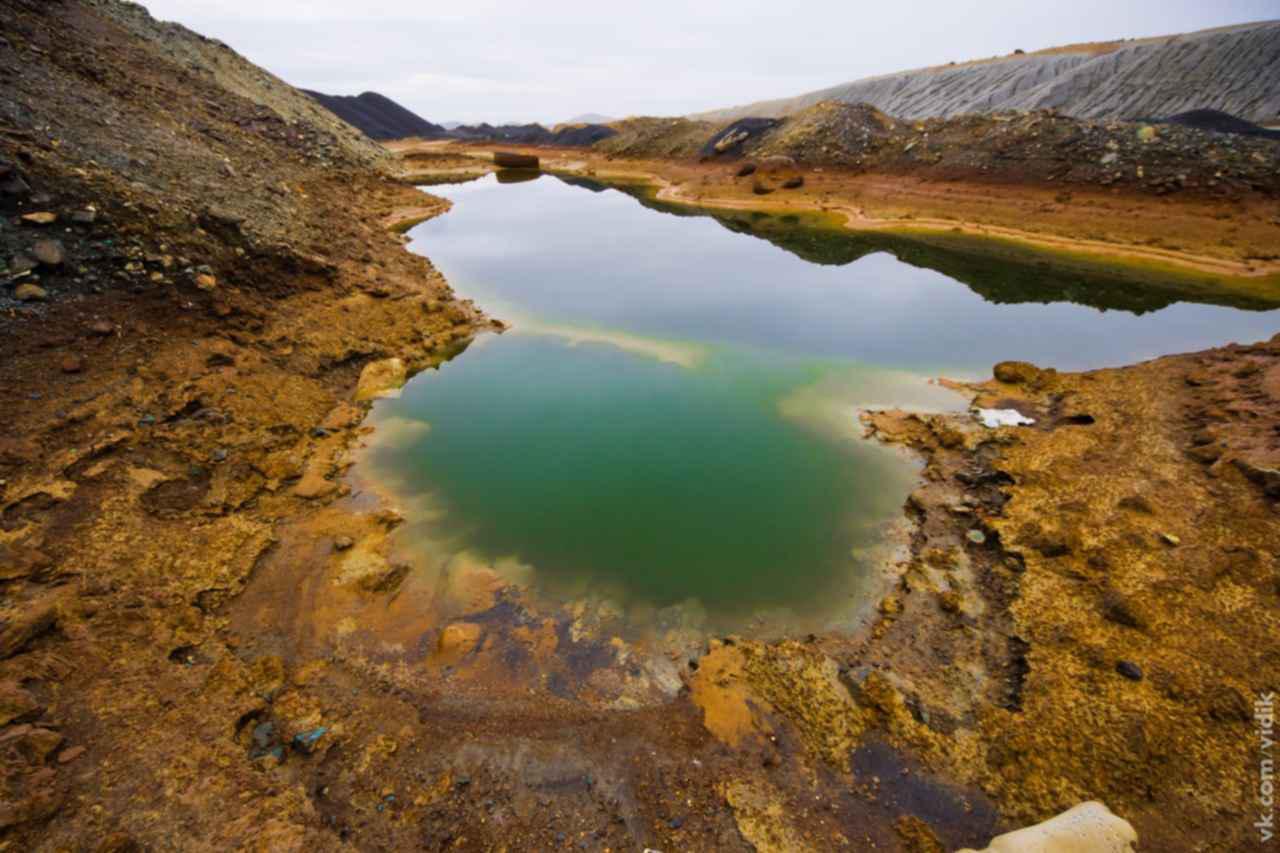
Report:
143,0,1280,123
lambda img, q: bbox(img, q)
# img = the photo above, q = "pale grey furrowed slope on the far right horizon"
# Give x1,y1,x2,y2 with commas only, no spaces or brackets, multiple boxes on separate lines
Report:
694,22,1280,123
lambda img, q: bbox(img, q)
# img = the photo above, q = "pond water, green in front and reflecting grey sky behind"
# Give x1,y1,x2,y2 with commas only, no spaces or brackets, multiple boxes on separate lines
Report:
369,177,1277,621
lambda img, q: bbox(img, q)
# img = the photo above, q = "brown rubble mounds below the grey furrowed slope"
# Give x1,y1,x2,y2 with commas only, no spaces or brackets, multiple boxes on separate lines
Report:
595,101,1280,204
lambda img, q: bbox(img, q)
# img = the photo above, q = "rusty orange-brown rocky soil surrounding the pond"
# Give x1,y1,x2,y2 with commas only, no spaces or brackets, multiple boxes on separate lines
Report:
0,129,1280,853
